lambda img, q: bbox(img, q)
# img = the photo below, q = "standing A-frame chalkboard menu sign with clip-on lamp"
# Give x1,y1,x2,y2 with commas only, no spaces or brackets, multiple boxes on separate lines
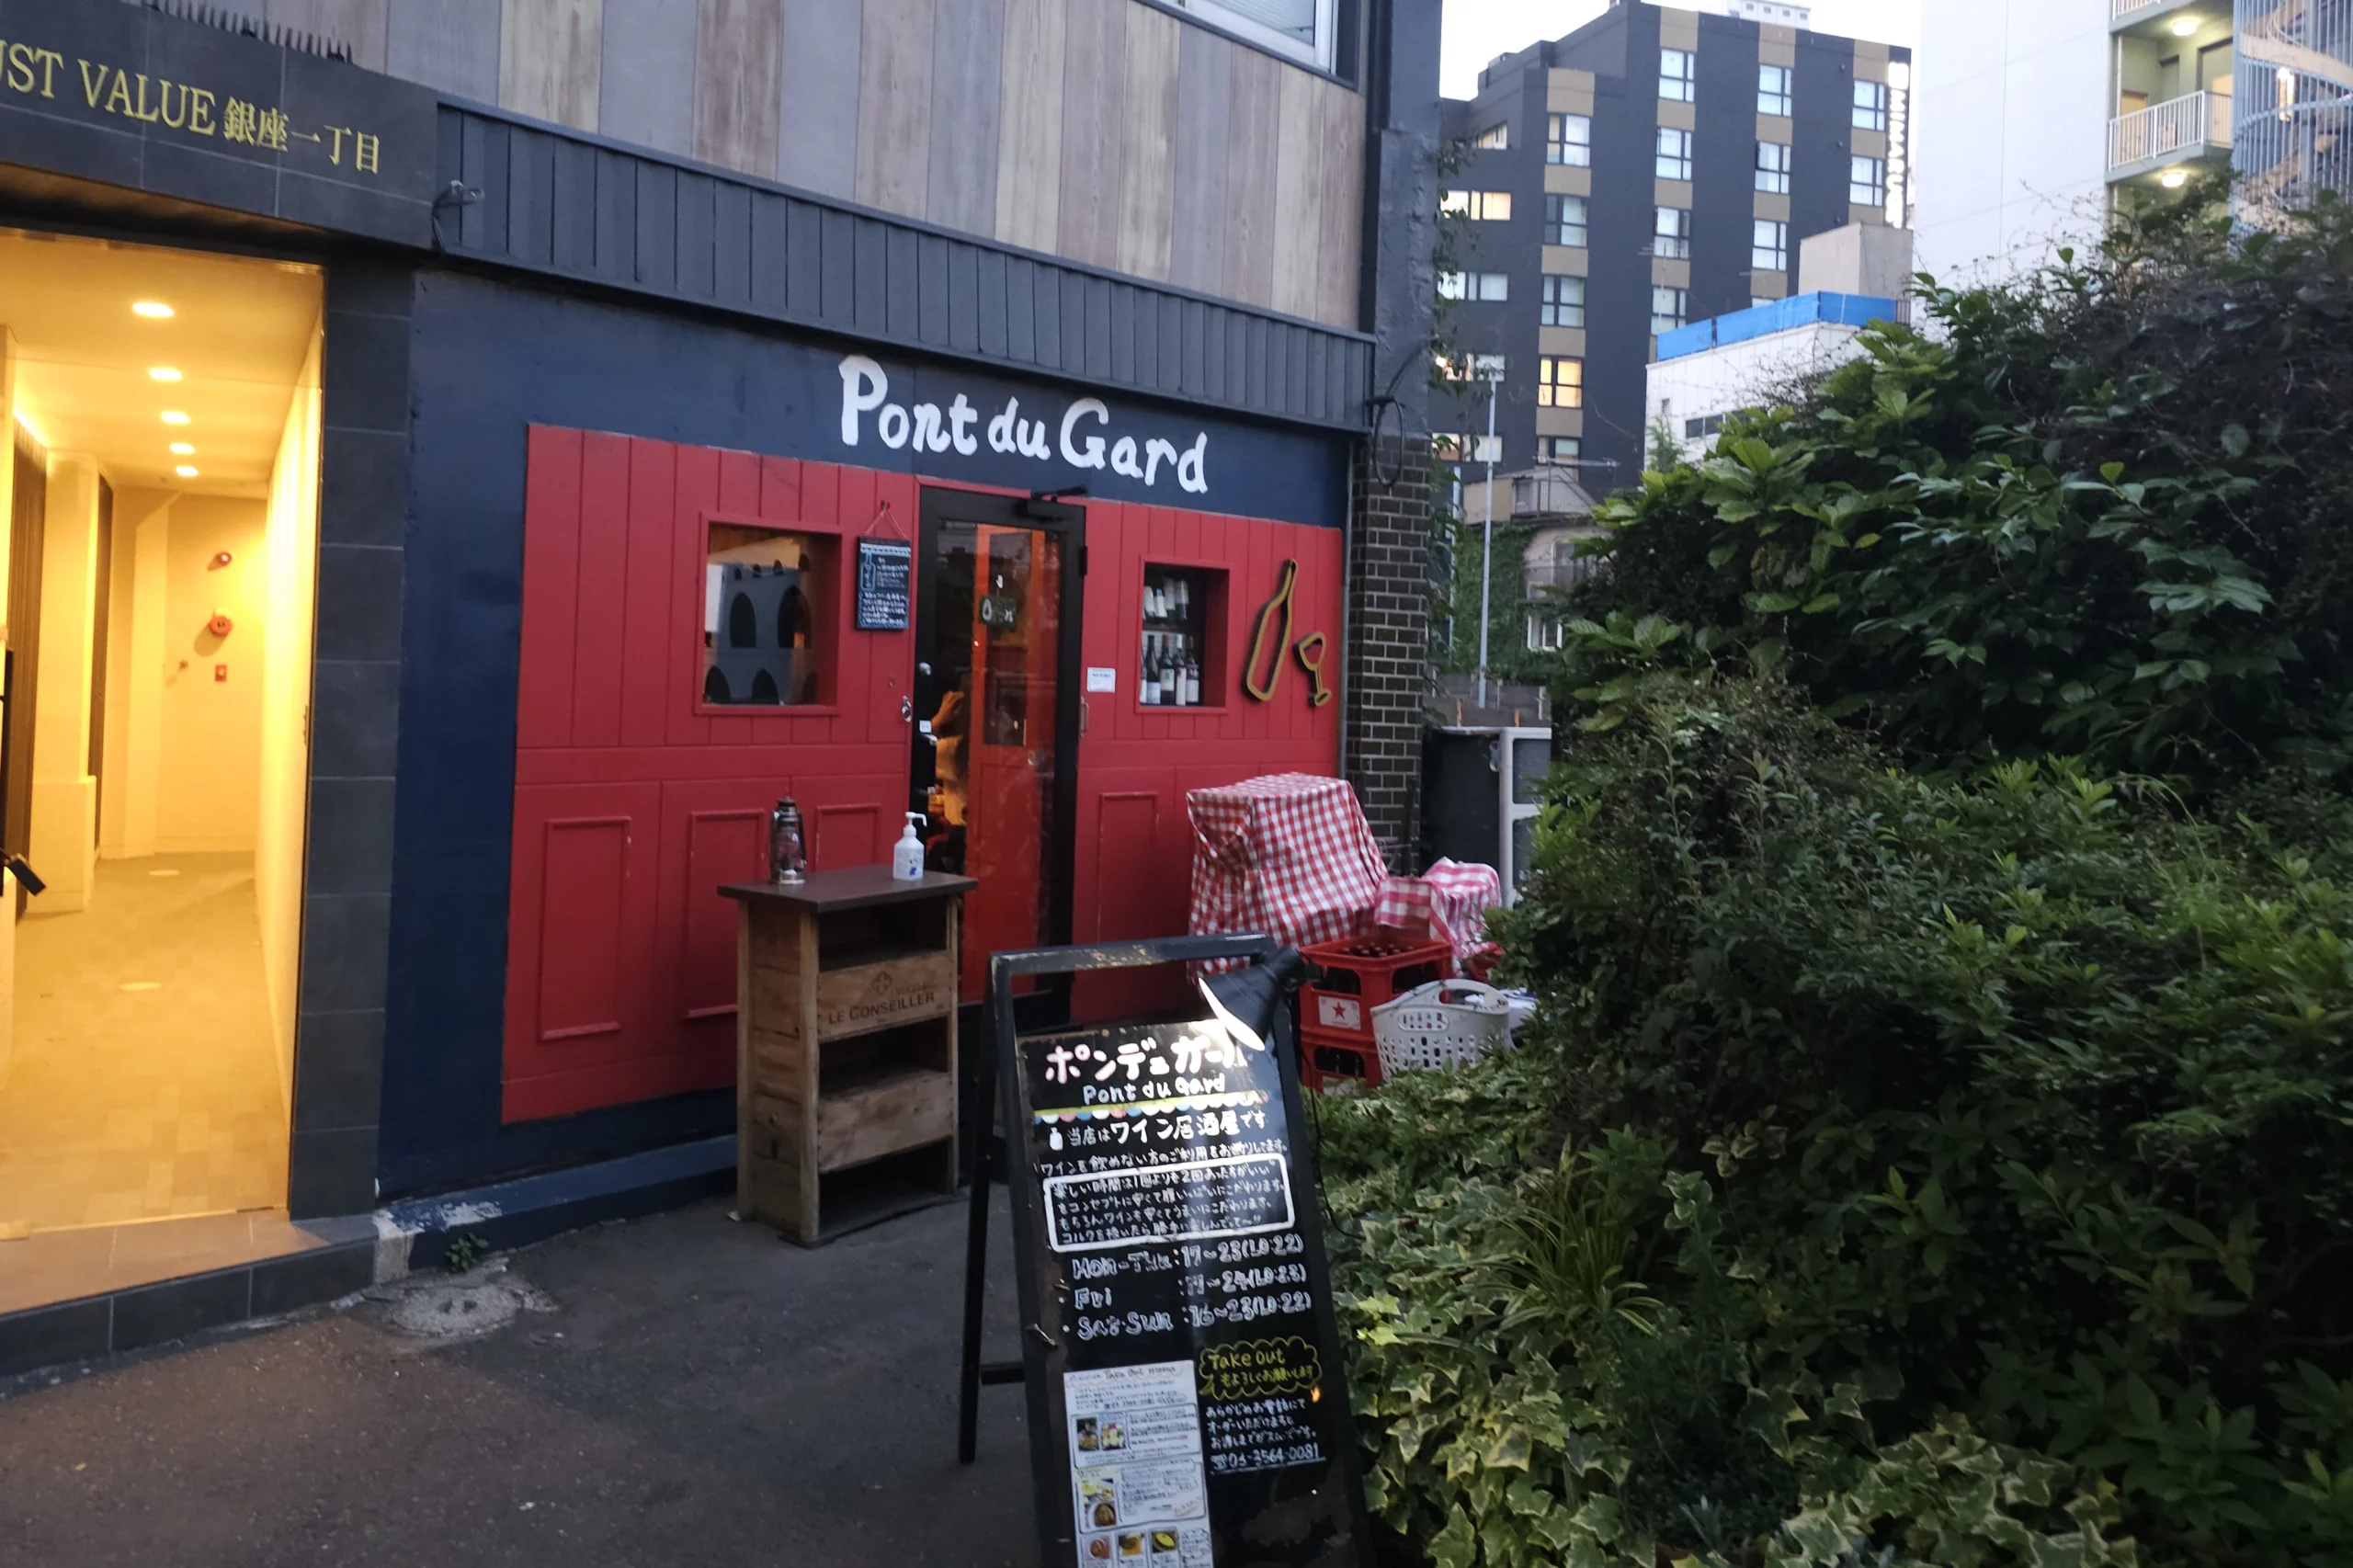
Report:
962,937,1371,1568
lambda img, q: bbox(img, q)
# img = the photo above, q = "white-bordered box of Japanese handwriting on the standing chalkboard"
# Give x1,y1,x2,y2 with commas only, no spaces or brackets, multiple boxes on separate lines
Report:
1045,1153,1294,1253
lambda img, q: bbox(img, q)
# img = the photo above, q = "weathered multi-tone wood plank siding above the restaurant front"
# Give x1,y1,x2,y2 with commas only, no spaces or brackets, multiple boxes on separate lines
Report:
367,0,1365,330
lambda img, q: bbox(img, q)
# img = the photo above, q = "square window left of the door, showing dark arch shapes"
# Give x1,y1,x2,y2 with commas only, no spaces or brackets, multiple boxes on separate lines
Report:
699,523,837,709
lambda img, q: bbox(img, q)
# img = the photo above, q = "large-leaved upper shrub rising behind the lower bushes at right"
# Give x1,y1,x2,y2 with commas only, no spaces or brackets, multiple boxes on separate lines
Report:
1560,189,2353,779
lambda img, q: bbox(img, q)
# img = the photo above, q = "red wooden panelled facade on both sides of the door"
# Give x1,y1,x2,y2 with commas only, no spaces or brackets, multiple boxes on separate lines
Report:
504,426,1341,1120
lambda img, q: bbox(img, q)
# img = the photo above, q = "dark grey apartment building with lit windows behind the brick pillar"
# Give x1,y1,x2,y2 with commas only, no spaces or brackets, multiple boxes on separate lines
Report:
1433,0,1911,490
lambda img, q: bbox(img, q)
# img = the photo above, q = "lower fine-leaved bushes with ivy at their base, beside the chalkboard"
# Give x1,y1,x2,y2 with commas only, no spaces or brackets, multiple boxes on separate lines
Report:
1323,674,2353,1568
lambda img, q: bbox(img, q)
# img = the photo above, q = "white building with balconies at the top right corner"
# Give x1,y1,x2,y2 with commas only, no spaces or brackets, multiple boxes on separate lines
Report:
1917,0,2353,280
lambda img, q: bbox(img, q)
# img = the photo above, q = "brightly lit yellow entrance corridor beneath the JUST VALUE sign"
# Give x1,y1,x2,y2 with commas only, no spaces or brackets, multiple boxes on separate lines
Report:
0,228,323,1312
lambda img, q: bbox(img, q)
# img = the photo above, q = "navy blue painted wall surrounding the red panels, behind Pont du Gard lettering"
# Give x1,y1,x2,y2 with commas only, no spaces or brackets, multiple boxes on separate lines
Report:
379,273,1346,1196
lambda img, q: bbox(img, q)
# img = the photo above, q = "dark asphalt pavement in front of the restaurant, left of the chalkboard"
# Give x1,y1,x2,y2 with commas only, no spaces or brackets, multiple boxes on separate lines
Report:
0,1203,1038,1568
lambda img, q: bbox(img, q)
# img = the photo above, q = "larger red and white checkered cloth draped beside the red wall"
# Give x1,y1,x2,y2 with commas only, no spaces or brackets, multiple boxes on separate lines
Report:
1186,772,1388,947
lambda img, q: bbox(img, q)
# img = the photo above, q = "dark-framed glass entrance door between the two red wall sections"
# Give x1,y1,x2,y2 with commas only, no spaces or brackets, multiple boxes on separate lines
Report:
908,490,1083,1003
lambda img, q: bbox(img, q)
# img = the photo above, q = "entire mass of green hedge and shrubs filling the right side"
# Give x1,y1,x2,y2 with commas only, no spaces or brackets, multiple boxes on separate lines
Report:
1320,191,2353,1568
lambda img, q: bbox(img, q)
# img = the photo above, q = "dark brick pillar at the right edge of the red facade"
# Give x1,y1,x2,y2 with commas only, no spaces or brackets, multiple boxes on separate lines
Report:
1344,437,1430,873
